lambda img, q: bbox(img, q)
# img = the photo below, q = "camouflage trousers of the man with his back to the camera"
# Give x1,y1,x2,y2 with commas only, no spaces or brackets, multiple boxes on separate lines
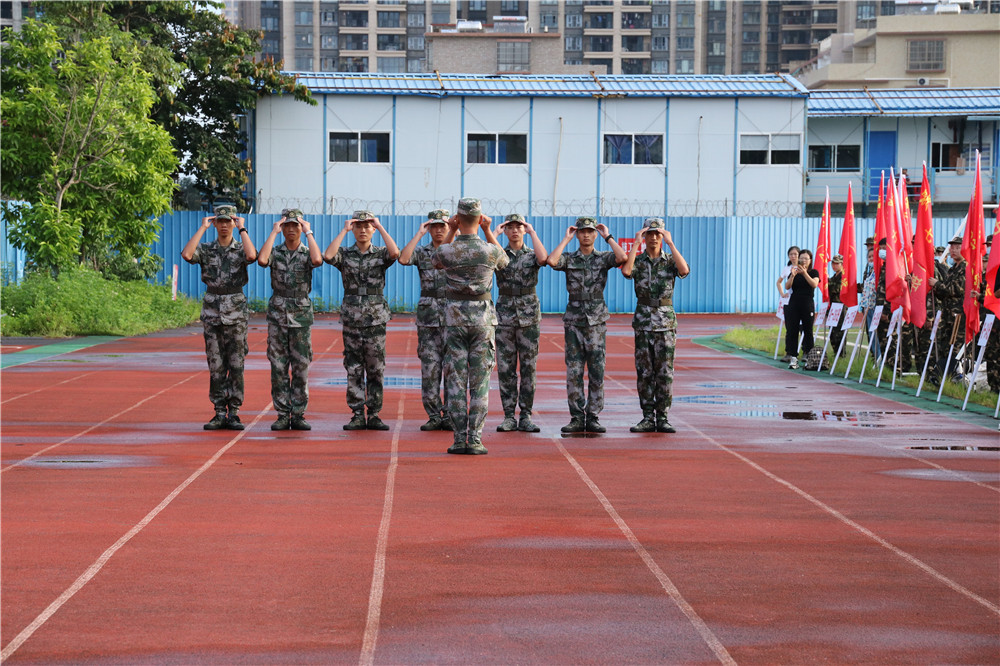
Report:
444,326,496,446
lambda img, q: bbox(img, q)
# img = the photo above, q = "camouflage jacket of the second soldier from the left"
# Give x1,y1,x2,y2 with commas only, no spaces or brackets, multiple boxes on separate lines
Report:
267,242,314,328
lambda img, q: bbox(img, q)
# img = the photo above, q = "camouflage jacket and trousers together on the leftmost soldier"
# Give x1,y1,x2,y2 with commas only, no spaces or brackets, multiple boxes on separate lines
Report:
189,238,251,416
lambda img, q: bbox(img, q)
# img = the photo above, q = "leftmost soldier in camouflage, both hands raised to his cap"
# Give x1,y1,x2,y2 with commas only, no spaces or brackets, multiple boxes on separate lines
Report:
181,206,257,430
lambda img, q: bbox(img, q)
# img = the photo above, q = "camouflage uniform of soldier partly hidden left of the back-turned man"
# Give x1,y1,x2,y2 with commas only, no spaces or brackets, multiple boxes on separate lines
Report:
410,245,448,418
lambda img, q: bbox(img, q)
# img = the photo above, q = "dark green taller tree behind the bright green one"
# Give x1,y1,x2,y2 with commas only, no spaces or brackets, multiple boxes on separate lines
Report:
42,0,316,210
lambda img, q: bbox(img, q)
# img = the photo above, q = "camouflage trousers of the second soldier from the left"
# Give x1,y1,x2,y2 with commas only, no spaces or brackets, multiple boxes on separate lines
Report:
267,322,312,416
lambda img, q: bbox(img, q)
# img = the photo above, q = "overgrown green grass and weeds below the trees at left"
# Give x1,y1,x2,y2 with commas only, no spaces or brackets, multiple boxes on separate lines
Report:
0,266,201,338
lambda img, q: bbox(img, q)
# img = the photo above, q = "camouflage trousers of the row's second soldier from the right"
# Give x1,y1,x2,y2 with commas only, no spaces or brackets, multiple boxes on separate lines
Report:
563,323,608,418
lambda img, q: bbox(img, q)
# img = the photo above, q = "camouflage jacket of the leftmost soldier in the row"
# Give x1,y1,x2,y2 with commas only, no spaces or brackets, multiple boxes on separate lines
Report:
189,238,252,326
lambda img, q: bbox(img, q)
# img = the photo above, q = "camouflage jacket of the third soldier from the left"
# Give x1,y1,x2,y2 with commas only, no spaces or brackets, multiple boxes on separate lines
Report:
326,245,396,327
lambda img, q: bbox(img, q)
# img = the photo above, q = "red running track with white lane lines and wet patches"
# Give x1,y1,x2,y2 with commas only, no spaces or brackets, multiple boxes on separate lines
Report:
0,315,1000,664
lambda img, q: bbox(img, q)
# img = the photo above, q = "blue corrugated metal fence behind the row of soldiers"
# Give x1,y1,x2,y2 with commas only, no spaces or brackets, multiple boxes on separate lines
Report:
153,212,962,312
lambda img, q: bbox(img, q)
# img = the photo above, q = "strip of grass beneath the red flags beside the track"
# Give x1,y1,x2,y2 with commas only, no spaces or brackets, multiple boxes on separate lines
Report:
722,324,997,409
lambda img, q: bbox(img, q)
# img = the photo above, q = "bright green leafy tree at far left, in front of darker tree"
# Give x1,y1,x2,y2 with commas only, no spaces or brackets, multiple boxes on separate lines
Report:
0,17,177,270
